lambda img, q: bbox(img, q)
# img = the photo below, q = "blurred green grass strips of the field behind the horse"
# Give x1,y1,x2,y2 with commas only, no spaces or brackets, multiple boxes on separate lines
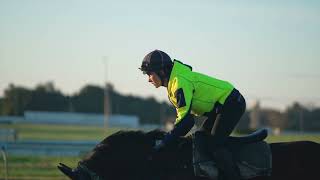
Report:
0,124,320,180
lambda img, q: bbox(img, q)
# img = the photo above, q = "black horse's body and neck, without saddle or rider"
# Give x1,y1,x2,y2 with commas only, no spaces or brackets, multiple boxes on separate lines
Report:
58,130,320,180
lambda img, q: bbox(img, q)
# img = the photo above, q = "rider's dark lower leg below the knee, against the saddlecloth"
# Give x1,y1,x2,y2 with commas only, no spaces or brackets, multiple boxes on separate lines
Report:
212,147,241,180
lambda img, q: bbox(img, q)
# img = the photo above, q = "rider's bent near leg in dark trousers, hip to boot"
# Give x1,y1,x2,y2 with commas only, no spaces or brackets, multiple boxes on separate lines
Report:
209,90,246,180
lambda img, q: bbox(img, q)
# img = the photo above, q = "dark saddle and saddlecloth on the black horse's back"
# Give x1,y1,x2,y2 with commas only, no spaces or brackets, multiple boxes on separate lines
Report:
192,129,272,180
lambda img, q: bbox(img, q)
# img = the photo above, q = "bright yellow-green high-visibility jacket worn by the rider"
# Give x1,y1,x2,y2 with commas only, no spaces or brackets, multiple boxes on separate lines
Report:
167,60,234,124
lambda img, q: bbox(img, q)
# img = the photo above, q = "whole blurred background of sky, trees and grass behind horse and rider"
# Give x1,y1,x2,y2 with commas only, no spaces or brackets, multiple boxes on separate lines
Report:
0,0,320,180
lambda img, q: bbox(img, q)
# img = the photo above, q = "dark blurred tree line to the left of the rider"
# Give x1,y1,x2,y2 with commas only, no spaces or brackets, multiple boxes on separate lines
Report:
0,82,175,123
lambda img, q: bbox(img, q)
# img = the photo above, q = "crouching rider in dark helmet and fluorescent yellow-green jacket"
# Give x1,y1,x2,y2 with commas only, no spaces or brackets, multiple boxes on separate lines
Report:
139,50,246,180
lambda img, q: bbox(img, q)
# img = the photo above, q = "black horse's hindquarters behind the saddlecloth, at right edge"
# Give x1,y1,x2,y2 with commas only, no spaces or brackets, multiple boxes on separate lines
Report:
270,141,320,180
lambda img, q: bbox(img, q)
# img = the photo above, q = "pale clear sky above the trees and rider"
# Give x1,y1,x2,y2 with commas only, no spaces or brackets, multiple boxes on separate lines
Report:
0,0,320,108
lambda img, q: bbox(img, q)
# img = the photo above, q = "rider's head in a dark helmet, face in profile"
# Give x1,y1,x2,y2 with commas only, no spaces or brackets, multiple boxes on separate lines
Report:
139,50,173,87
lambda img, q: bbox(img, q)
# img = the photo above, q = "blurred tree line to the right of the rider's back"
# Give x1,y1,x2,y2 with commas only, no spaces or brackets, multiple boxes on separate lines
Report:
238,102,320,132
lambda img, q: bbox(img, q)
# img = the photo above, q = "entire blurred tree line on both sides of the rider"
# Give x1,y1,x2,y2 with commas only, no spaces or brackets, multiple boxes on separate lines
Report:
0,82,320,131
